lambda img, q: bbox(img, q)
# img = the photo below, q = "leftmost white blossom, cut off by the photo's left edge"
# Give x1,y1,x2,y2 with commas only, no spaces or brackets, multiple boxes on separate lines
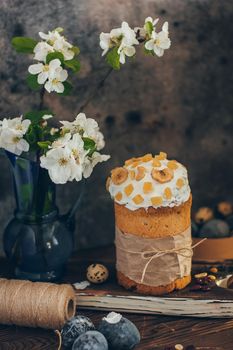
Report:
0,116,31,156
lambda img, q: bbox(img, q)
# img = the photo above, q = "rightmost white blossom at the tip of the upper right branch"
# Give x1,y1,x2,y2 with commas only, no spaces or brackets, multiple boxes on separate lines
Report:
145,22,171,57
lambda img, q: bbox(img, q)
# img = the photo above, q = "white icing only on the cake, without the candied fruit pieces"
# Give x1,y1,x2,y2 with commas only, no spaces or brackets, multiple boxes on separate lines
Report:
109,156,191,210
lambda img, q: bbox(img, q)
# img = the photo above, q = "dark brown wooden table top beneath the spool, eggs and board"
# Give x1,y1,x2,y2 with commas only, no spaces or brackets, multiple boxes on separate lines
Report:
0,247,233,350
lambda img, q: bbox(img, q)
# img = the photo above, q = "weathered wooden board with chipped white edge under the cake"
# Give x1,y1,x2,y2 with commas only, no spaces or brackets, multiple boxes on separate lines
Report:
73,263,233,318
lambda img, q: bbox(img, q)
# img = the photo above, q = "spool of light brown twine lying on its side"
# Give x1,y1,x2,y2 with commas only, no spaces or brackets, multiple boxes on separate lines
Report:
0,279,76,329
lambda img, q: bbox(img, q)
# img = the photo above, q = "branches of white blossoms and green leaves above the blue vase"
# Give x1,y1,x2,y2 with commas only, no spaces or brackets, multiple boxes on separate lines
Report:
0,17,171,184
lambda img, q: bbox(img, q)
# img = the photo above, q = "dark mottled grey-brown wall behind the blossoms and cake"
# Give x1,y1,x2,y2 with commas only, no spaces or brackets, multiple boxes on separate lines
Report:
0,0,233,256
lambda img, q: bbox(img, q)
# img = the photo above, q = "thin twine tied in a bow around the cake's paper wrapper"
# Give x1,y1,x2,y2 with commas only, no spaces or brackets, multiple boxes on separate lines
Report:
118,238,206,283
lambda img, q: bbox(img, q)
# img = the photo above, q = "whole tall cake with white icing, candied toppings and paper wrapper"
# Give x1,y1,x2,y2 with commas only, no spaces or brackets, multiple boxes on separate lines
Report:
106,152,192,295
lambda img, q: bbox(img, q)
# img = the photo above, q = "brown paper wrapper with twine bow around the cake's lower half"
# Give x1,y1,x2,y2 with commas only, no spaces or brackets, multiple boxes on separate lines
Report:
116,227,206,286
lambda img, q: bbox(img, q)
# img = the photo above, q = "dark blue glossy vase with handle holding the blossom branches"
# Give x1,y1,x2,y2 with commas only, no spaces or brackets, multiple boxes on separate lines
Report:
3,152,82,281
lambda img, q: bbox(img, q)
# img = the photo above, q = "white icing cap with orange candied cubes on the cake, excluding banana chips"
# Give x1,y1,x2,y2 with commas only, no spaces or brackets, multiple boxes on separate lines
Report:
108,153,191,210
